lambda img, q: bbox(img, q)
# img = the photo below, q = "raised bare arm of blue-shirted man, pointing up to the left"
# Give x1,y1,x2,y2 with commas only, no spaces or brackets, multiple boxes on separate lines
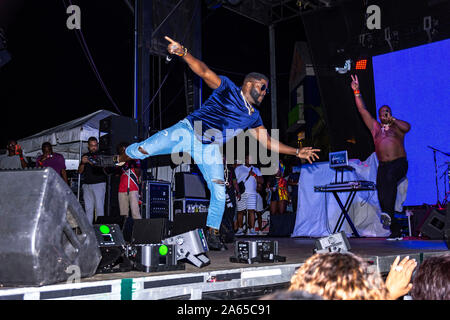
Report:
164,36,221,89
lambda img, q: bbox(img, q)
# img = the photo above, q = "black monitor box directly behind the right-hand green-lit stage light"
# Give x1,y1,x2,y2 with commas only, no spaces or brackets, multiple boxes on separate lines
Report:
132,218,169,244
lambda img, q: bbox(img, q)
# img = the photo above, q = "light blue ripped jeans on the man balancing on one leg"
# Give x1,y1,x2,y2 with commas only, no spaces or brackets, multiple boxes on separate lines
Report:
125,119,225,229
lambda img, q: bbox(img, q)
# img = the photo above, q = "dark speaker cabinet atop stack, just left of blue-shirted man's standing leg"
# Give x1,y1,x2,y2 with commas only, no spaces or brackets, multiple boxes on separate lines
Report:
175,172,206,199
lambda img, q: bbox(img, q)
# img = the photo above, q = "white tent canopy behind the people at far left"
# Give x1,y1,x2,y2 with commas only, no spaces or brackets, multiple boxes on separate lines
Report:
17,110,116,160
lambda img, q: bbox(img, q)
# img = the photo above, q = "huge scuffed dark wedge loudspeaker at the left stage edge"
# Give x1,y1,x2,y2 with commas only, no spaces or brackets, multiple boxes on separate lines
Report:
0,168,101,286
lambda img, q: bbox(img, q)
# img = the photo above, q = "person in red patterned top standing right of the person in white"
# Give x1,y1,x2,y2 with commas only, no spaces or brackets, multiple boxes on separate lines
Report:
267,161,290,215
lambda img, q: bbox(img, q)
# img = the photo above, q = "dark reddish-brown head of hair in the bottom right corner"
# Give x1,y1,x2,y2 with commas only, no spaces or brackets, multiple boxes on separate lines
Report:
411,254,450,300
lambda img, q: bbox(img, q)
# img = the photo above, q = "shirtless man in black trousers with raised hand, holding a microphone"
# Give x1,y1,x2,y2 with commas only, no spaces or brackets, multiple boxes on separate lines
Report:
351,75,411,240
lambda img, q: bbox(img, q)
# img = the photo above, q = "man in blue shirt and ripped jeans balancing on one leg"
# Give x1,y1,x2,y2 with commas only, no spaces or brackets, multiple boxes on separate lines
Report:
119,37,320,250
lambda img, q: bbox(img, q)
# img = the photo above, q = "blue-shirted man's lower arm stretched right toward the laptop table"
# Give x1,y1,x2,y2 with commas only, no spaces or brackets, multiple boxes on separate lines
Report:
250,126,320,163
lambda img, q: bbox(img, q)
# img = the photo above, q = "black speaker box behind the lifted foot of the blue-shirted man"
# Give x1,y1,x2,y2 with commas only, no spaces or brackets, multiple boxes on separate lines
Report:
99,115,138,155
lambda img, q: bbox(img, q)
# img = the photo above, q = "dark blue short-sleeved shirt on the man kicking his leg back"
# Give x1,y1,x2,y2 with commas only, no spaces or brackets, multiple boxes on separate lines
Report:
186,76,263,144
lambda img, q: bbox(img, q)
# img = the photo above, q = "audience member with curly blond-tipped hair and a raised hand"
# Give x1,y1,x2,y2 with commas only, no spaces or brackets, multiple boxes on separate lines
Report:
288,252,417,300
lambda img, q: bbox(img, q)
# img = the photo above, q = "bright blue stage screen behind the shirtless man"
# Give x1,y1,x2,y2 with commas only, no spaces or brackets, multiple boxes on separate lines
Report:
373,39,450,205
